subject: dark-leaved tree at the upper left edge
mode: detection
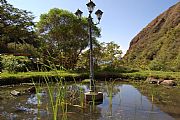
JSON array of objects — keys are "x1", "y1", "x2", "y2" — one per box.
[{"x1": 0, "y1": 0, "x2": 37, "y2": 53}]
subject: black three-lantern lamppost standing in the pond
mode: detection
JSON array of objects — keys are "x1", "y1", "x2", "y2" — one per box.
[{"x1": 75, "y1": 0, "x2": 103, "y2": 100}]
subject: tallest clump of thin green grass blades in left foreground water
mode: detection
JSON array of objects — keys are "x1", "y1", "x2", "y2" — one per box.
[{"x1": 30, "y1": 55, "x2": 67, "y2": 120}]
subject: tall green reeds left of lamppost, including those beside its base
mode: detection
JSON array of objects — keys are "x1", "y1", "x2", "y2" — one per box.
[{"x1": 32, "y1": 55, "x2": 89, "y2": 120}]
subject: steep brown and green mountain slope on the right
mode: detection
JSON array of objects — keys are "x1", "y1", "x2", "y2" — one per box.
[{"x1": 123, "y1": 2, "x2": 180, "y2": 71}]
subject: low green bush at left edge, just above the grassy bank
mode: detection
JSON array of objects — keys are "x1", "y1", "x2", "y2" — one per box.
[{"x1": 1, "y1": 55, "x2": 31, "y2": 73}]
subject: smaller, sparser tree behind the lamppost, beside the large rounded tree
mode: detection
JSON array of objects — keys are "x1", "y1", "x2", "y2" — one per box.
[{"x1": 78, "y1": 42, "x2": 122, "y2": 69}]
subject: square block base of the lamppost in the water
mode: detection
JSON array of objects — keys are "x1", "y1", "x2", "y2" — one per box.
[{"x1": 84, "y1": 91, "x2": 103, "y2": 102}]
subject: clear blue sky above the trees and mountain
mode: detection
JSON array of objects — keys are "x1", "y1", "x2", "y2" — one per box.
[{"x1": 7, "y1": 0, "x2": 179, "y2": 54}]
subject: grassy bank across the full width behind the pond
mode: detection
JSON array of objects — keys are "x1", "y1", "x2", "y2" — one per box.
[{"x1": 0, "y1": 71, "x2": 180, "y2": 85}]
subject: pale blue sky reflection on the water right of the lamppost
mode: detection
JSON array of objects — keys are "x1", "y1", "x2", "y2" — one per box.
[{"x1": 100, "y1": 85, "x2": 173, "y2": 120}]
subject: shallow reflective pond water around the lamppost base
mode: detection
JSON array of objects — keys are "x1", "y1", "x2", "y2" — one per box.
[{"x1": 0, "y1": 82, "x2": 180, "y2": 120}]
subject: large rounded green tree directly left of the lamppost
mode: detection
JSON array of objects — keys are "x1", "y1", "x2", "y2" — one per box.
[{"x1": 37, "y1": 8, "x2": 100, "y2": 69}]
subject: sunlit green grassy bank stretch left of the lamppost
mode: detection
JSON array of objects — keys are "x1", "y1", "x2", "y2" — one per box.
[{"x1": 0, "y1": 71, "x2": 83, "y2": 86}]
